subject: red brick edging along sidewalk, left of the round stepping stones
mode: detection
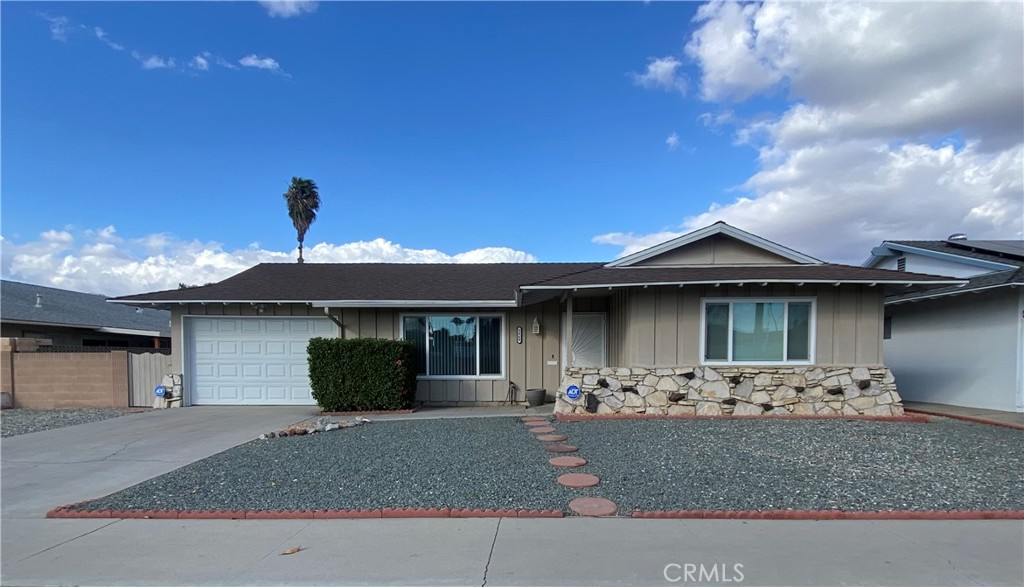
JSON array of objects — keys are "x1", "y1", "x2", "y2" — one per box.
[{"x1": 46, "y1": 506, "x2": 565, "y2": 519}]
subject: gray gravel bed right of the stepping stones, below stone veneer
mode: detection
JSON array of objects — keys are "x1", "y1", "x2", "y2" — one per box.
[{"x1": 559, "y1": 419, "x2": 1024, "y2": 515}]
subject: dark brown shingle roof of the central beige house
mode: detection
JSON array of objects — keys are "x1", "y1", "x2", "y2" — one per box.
[{"x1": 115, "y1": 263, "x2": 957, "y2": 302}]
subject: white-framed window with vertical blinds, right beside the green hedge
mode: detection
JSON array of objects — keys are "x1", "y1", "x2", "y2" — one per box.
[{"x1": 401, "y1": 313, "x2": 505, "y2": 379}]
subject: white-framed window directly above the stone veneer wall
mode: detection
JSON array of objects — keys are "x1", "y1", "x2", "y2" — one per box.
[{"x1": 700, "y1": 298, "x2": 815, "y2": 365}]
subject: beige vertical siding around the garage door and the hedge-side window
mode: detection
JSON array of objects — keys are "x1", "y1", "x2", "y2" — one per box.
[{"x1": 171, "y1": 300, "x2": 569, "y2": 404}]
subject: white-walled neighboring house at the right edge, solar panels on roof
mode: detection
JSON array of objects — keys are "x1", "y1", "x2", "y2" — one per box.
[{"x1": 863, "y1": 235, "x2": 1024, "y2": 412}]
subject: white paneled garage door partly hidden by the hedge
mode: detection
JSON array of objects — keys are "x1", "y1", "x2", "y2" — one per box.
[{"x1": 185, "y1": 318, "x2": 336, "y2": 406}]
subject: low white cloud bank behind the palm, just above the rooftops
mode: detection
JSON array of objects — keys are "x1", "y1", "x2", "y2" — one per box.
[{"x1": 0, "y1": 226, "x2": 537, "y2": 295}]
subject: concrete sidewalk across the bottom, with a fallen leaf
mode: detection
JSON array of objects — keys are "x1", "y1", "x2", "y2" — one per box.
[{"x1": 0, "y1": 518, "x2": 1024, "y2": 586}]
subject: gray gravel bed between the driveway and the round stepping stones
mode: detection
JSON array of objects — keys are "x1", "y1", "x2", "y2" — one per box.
[{"x1": 70, "y1": 418, "x2": 575, "y2": 510}]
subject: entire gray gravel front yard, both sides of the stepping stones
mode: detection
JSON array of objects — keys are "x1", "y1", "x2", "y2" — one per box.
[{"x1": 64, "y1": 418, "x2": 1024, "y2": 515}]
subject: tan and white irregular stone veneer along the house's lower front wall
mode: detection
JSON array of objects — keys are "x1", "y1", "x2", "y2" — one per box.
[{"x1": 555, "y1": 366, "x2": 903, "y2": 416}]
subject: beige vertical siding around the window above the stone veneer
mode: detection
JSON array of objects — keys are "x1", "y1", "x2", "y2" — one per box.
[{"x1": 609, "y1": 284, "x2": 884, "y2": 367}]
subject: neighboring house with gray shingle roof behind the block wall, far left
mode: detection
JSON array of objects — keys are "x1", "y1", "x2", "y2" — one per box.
[{"x1": 0, "y1": 281, "x2": 171, "y2": 348}]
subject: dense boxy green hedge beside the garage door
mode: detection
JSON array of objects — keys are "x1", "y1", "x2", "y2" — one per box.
[{"x1": 307, "y1": 338, "x2": 416, "y2": 412}]
